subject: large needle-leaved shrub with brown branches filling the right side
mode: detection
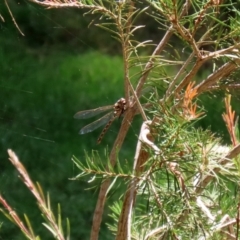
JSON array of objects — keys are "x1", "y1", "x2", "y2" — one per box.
[{"x1": 1, "y1": 0, "x2": 240, "y2": 240}]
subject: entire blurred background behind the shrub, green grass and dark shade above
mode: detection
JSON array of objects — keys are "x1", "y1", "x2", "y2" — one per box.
[{"x1": 0, "y1": 1, "x2": 240, "y2": 240}]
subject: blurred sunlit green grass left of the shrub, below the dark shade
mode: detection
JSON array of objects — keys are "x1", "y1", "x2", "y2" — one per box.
[{"x1": 0, "y1": 44, "x2": 139, "y2": 239}]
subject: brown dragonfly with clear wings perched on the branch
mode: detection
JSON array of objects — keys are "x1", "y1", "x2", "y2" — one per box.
[{"x1": 74, "y1": 98, "x2": 127, "y2": 144}]
